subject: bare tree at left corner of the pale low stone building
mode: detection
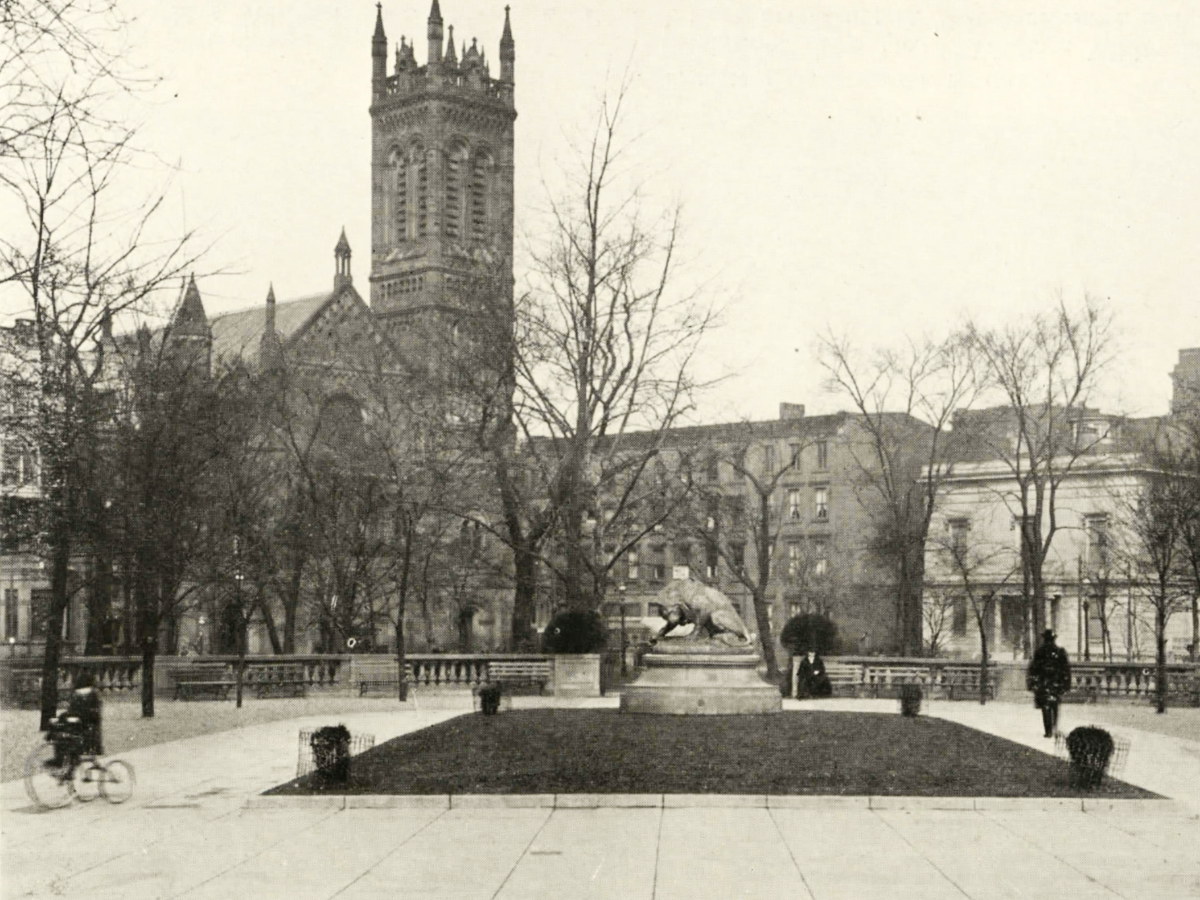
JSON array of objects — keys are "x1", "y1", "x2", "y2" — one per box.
[{"x1": 820, "y1": 334, "x2": 984, "y2": 654}]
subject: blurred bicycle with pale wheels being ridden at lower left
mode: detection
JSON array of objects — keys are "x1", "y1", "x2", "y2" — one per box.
[{"x1": 25, "y1": 719, "x2": 136, "y2": 809}]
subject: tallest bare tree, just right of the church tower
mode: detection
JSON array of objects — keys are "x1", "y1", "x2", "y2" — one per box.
[{"x1": 451, "y1": 89, "x2": 714, "y2": 646}]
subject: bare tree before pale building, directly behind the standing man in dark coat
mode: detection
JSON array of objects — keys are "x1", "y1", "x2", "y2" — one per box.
[{"x1": 964, "y1": 298, "x2": 1111, "y2": 655}]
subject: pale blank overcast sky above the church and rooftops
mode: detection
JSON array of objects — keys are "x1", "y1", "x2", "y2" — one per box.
[{"x1": 4, "y1": 0, "x2": 1200, "y2": 421}]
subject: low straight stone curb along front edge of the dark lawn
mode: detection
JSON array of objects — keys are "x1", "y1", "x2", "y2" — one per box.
[{"x1": 244, "y1": 793, "x2": 1189, "y2": 815}]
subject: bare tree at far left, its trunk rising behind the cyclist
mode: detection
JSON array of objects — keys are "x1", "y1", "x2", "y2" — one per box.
[{"x1": 0, "y1": 81, "x2": 194, "y2": 726}]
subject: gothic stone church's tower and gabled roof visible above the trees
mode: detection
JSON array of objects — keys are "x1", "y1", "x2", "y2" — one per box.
[{"x1": 170, "y1": 0, "x2": 516, "y2": 650}]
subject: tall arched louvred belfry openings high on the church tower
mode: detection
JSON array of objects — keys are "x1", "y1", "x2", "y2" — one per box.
[{"x1": 383, "y1": 142, "x2": 498, "y2": 246}]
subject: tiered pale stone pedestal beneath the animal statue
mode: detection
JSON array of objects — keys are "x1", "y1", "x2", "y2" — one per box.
[{"x1": 620, "y1": 640, "x2": 784, "y2": 715}]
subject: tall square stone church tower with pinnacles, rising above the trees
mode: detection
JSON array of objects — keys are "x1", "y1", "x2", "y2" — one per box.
[{"x1": 371, "y1": 0, "x2": 516, "y2": 357}]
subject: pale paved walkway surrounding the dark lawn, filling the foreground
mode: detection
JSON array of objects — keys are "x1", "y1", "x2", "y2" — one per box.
[{"x1": 0, "y1": 701, "x2": 1200, "y2": 900}]
